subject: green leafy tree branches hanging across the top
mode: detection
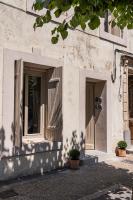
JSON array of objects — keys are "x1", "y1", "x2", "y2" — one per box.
[{"x1": 33, "y1": 0, "x2": 133, "y2": 44}]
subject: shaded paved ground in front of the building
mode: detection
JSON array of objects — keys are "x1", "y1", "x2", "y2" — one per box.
[{"x1": 0, "y1": 155, "x2": 133, "y2": 200}]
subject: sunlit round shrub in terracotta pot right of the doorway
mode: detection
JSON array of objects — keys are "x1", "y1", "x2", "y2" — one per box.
[{"x1": 116, "y1": 141, "x2": 127, "y2": 157}]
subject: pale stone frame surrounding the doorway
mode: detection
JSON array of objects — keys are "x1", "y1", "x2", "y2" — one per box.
[{"x1": 79, "y1": 69, "x2": 113, "y2": 153}]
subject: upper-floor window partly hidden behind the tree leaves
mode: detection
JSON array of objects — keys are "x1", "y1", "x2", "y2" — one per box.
[{"x1": 104, "y1": 11, "x2": 123, "y2": 38}]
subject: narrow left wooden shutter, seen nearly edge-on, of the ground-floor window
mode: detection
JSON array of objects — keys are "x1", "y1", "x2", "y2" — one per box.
[{"x1": 14, "y1": 60, "x2": 23, "y2": 147}]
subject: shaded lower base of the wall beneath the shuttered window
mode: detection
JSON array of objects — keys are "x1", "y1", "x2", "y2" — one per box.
[{"x1": 0, "y1": 151, "x2": 62, "y2": 181}]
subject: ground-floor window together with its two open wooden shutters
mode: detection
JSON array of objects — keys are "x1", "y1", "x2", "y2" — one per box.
[{"x1": 14, "y1": 60, "x2": 62, "y2": 147}]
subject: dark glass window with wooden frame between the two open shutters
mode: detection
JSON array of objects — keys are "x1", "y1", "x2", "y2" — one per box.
[{"x1": 23, "y1": 71, "x2": 46, "y2": 136}]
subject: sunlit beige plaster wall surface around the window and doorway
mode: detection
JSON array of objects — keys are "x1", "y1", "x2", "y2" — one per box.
[{"x1": 0, "y1": 0, "x2": 133, "y2": 178}]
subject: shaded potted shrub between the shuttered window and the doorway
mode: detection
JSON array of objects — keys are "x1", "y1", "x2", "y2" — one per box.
[{"x1": 69, "y1": 149, "x2": 80, "y2": 169}]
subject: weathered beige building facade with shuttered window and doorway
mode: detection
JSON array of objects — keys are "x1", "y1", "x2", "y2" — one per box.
[{"x1": 0, "y1": 0, "x2": 133, "y2": 180}]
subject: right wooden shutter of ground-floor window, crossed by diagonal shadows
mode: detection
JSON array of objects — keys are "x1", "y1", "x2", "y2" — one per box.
[{"x1": 46, "y1": 67, "x2": 62, "y2": 141}]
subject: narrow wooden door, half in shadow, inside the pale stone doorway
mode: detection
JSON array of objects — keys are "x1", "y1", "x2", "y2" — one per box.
[{"x1": 85, "y1": 82, "x2": 95, "y2": 149}]
